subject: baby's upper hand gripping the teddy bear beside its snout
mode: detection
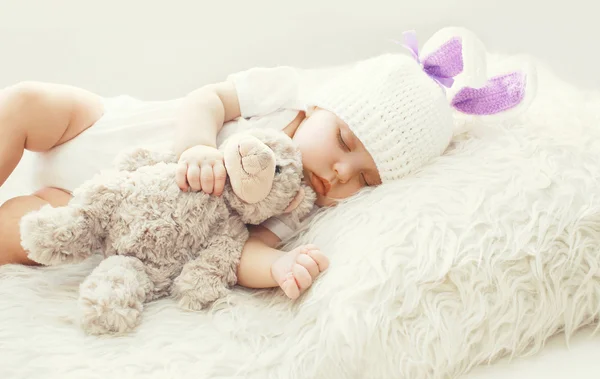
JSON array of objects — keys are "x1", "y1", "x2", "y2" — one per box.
[{"x1": 175, "y1": 145, "x2": 227, "y2": 196}]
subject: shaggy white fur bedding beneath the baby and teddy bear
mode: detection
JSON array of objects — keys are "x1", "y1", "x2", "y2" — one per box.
[{"x1": 0, "y1": 57, "x2": 600, "y2": 379}]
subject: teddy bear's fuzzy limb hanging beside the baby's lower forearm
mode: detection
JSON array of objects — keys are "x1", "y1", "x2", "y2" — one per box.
[{"x1": 172, "y1": 237, "x2": 244, "y2": 310}]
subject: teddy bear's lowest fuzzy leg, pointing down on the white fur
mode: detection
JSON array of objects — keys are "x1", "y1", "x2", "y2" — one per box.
[{"x1": 79, "y1": 255, "x2": 154, "y2": 334}]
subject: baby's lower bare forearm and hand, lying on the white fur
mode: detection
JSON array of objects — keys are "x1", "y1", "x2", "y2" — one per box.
[{"x1": 237, "y1": 226, "x2": 329, "y2": 299}]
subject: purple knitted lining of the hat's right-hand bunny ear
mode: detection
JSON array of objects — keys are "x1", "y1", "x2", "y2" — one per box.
[{"x1": 451, "y1": 72, "x2": 527, "y2": 115}]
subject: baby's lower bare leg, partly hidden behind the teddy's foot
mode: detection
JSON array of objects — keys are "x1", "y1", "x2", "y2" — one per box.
[{"x1": 0, "y1": 188, "x2": 71, "y2": 265}]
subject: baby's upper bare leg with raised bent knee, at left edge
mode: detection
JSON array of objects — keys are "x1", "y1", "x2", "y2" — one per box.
[{"x1": 0, "y1": 83, "x2": 104, "y2": 186}]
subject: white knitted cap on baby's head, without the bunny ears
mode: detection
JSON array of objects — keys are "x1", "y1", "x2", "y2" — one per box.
[{"x1": 308, "y1": 54, "x2": 453, "y2": 183}]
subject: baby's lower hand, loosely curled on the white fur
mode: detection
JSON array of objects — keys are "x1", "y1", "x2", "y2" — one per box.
[{"x1": 271, "y1": 245, "x2": 329, "y2": 300}]
